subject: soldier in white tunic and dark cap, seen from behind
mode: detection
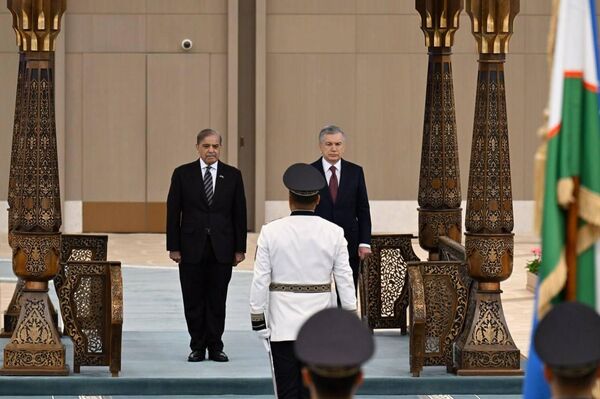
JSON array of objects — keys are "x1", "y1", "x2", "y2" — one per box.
[{"x1": 250, "y1": 164, "x2": 356, "y2": 399}]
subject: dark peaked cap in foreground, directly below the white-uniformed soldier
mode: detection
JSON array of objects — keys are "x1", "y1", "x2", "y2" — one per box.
[{"x1": 295, "y1": 308, "x2": 375, "y2": 377}]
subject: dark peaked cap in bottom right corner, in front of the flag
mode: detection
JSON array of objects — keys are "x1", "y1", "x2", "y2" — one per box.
[{"x1": 533, "y1": 302, "x2": 600, "y2": 377}]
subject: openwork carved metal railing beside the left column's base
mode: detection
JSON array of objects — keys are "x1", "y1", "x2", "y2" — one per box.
[{"x1": 54, "y1": 235, "x2": 123, "y2": 375}]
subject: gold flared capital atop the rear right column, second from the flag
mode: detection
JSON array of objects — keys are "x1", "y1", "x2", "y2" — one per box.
[{"x1": 415, "y1": 0, "x2": 463, "y2": 47}]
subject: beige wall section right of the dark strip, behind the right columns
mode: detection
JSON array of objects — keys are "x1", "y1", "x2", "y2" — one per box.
[{"x1": 266, "y1": 0, "x2": 550, "y2": 200}]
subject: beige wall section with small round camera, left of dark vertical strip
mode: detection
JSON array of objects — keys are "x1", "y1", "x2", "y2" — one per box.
[{"x1": 65, "y1": 0, "x2": 227, "y2": 202}]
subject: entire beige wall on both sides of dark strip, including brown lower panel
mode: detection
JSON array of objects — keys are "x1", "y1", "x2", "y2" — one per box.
[{"x1": 0, "y1": 0, "x2": 564, "y2": 231}]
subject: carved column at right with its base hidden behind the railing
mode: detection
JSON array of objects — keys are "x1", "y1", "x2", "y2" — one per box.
[{"x1": 415, "y1": 0, "x2": 463, "y2": 260}]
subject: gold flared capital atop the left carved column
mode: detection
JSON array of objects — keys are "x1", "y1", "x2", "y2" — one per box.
[{"x1": 7, "y1": 0, "x2": 67, "y2": 51}]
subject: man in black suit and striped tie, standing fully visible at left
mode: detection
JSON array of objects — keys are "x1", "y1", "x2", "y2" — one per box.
[{"x1": 167, "y1": 129, "x2": 247, "y2": 362}]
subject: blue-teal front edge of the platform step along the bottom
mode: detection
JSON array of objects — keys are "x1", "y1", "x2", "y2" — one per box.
[{"x1": 0, "y1": 377, "x2": 523, "y2": 396}]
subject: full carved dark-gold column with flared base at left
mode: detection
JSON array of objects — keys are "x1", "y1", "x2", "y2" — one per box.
[{"x1": 0, "y1": 0, "x2": 69, "y2": 375}]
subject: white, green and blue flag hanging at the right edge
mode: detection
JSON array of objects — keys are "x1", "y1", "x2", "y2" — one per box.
[{"x1": 523, "y1": 0, "x2": 600, "y2": 399}]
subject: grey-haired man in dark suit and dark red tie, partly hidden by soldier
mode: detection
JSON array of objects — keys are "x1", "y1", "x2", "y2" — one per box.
[{"x1": 312, "y1": 125, "x2": 371, "y2": 288}]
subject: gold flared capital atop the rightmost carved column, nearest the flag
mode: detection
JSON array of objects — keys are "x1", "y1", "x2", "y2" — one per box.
[{"x1": 466, "y1": 0, "x2": 520, "y2": 54}]
